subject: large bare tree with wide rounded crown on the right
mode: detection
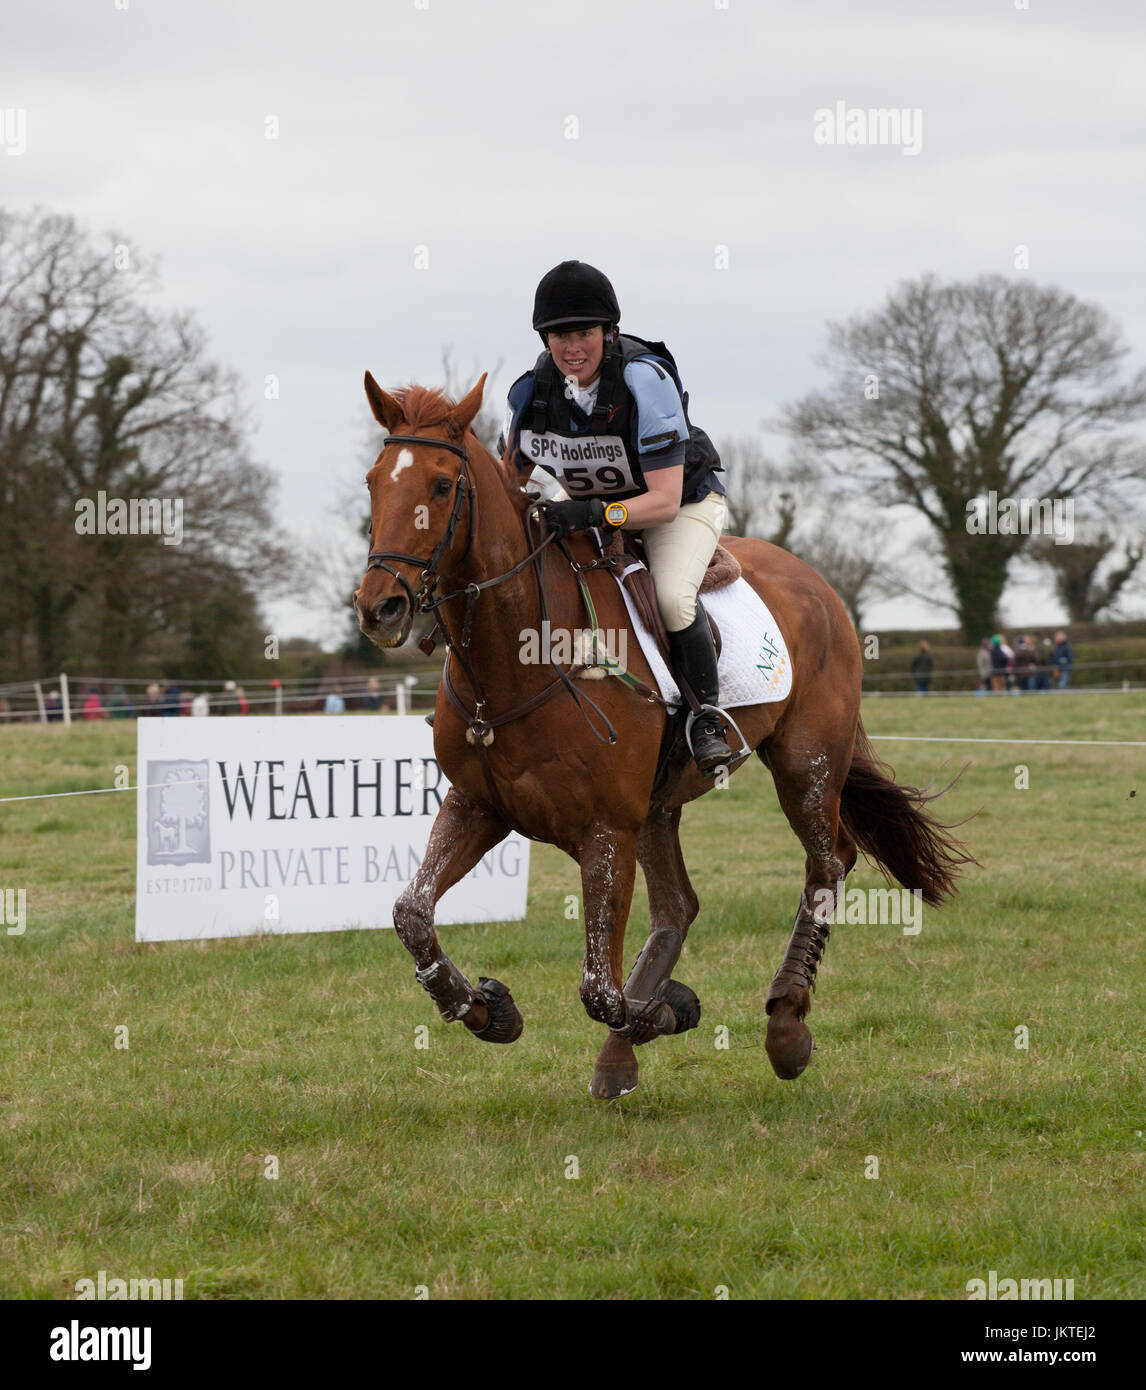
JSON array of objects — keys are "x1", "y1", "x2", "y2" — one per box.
[{"x1": 784, "y1": 275, "x2": 1146, "y2": 639}]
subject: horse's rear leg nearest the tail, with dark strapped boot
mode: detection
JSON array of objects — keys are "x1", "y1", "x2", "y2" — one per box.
[{"x1": 758, "y1": 731, "x2": 855, "y2": 1081}]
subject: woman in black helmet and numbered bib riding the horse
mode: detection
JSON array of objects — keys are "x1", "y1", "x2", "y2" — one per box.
[{"x1": 498, "y1": 261, "x2": 732, "y2": 776}]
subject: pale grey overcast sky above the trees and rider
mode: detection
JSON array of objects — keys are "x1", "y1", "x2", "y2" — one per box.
[{"x1": 0, "y1": 0, "x2": 1146, "y2": 637}]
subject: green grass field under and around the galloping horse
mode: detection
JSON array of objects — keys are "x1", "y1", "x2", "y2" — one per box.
[{"x1": 0, "y1": 694, "x2": 1146, "y2": 1300}]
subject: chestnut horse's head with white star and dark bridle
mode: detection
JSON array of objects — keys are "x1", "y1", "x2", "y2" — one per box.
[{"x1": 353, "y1": 371, "x2": 485, "y2": 646}]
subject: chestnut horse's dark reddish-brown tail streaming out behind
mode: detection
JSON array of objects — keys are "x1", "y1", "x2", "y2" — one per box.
[{"x1": 840, "y1": 721, "x2": 979, "y2": 906}]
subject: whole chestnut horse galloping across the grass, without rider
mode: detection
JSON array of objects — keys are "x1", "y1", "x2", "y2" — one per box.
[{"x1": 353, "y1": 373, "x2": 971, "y2": 1097}]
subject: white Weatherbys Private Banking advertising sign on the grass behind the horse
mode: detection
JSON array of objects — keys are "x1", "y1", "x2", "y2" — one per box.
[{"x1": 135, "y1": 714, "x2": 530, "y2": 941}]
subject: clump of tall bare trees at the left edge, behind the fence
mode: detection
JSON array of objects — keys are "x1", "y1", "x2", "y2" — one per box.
[{"x1": 0, "y1": 211, "x2": 285, "y2": 674}]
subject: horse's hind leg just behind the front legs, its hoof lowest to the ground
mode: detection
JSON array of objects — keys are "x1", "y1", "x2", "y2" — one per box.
[{"x1": 590, "y1": 808, "x2": 700, "y2": 1097}]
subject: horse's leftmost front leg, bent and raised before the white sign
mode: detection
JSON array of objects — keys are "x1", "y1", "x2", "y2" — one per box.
[{"x1": 394, "y1": 787, "x2": 522, "y2": 1043}]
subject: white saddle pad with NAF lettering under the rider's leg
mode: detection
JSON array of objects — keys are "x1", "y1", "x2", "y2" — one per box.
[{"x1": 618, "y1": 564, "x2": 791, "y2": 709}]
